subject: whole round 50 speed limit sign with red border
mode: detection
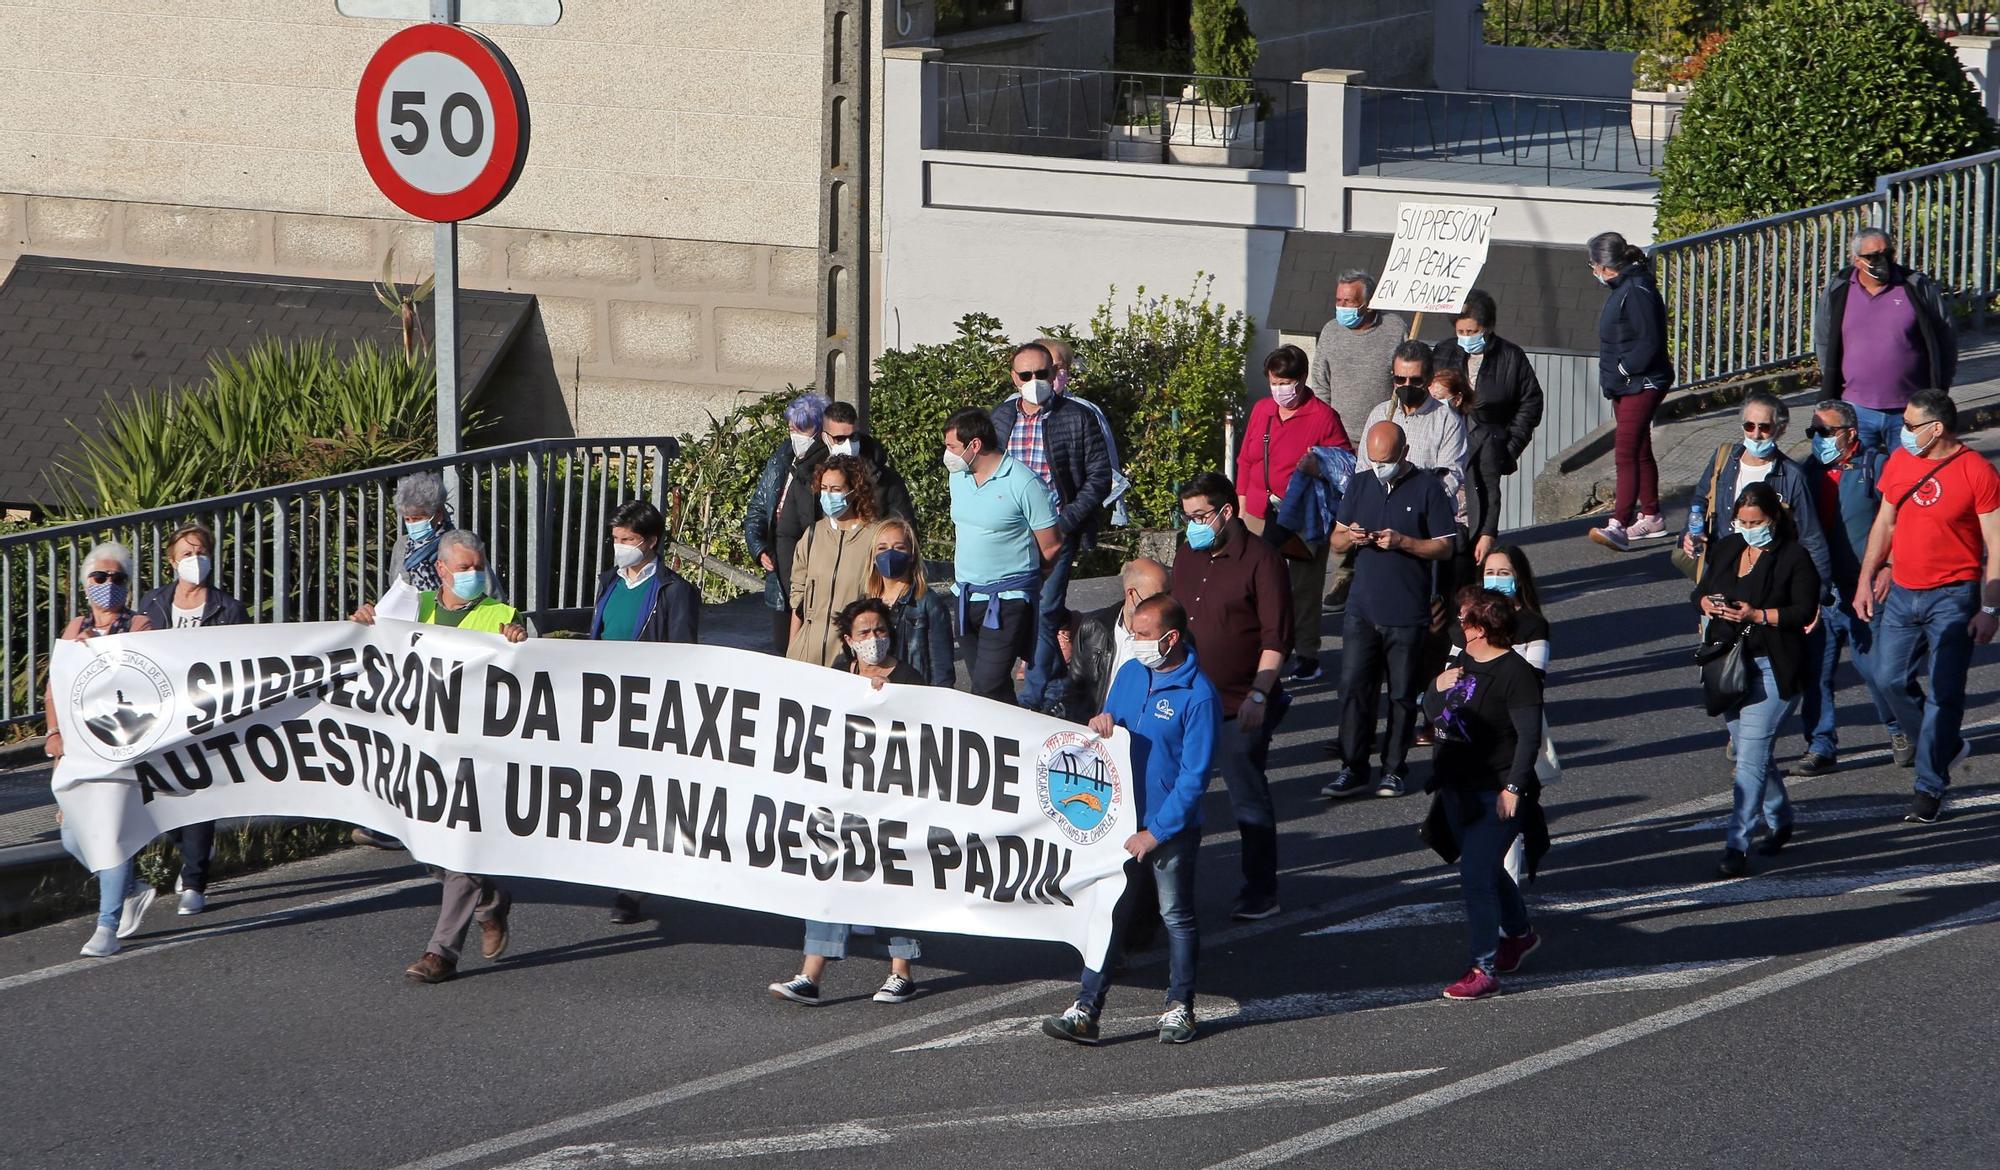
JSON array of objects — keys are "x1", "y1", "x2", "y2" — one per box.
[{"x1": 354, "y1": 24, "x2": 528, "y2": 224}]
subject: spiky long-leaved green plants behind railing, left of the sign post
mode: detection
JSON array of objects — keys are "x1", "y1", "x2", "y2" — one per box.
[{"x1": 48, "y1": 338, "x2": 480, "y2": 518}]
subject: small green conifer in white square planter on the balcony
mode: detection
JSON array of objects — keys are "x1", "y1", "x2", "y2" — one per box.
[{"x1": 1166, "y1": 0, "x2": 1264, "y2": 166}]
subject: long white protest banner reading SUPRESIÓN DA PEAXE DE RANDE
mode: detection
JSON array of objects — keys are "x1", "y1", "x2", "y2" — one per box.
[{"x1": 52, "y1": 622, "x2": 1136, "y2": 966}]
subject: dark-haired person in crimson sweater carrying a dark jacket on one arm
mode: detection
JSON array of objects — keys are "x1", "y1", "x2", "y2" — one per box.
[{"x1": 1236, "y1": 346, "x2": 1354, "y2": 682}]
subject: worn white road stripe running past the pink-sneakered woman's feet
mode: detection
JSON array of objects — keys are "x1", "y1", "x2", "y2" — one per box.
[{"x1": 896, "y1": 958, "x2": 1764, "y2": 1052}]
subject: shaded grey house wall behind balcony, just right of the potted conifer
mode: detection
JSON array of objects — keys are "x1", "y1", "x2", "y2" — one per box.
[{"x1": 1240, "y1": 0, "x2": 1432, "y2": 86}]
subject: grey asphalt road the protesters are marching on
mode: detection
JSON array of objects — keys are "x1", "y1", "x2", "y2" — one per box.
[{"x1": 0, "y1": 524, "x2": 2000, "y2": 1170}]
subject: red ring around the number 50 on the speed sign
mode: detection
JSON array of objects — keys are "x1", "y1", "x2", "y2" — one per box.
[{"x1": 354, "y1": 24, "x2": 528, "y2": 224}]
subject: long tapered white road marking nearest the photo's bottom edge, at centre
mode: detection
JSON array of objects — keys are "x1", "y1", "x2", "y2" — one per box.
[{"x1": 504, "y1": 1068, "x2": 1440, "y2": 1170}]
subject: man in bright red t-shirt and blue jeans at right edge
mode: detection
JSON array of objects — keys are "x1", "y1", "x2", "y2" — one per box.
[{"x1": 1854, "y1": 390, "x2": 2000, "y2": 824}]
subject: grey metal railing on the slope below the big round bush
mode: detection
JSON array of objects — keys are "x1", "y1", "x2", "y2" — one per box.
[{"x1": 1650, "y1": 150, "x2": 2000, "y2": 386}]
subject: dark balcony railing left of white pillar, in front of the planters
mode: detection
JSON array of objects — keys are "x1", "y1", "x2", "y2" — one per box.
[{"x1": 924, "y1": 62, "x2": 1306, "y2": 170}]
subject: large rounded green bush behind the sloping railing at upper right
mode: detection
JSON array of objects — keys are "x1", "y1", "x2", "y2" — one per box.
[{"x1": 1654, "y1": 0, "x2": 1994, "y2": 240}]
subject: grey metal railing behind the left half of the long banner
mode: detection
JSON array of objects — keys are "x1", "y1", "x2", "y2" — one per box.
[{"x1": 0, "y1": 436, "x2": 680, "y2": 726}]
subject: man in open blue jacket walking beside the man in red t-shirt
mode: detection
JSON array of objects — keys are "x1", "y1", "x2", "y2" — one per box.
[{"x1": 1792, "y1": 398, "x2": 1924, "y2": 776}]
